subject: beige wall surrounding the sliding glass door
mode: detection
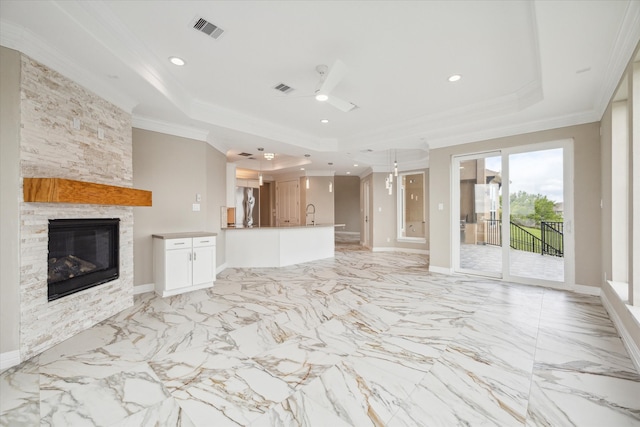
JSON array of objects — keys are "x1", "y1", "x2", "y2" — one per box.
[{"x1": 429, "y1": 123, "x2": 602, "y2": 287}]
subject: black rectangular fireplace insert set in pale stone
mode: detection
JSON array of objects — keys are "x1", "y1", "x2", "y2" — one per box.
[{"x1": 47, "y1": 218, "x2": 120, "y2": 301}]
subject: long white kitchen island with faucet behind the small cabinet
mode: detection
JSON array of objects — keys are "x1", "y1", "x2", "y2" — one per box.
[{"x1": 225, "y1": 224, "x2": 339, "y2": 268}]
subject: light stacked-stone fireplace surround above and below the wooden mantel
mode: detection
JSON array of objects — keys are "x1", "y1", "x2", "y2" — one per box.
[{"x1": 19, "y1": 55, "x2": 133, "y2": 360}]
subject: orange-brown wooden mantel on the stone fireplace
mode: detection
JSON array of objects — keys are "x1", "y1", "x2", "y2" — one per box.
[{"x1": 23, "y1": 178, "x2": 151, "y2": 206}]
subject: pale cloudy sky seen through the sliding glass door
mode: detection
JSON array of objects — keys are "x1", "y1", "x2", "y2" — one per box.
[{"x1": 485, "y1": 148, "x2": 564, "y2": 203}]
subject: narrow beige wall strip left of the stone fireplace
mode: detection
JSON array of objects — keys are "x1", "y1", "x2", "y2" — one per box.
[{"x1": 0, "y1": 47, "x2": 21, "y2": 354}]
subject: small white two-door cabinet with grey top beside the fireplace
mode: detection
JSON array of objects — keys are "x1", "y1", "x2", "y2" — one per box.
[{"x1": 153, "y1": 233, "x2": 216, "y2": 297}]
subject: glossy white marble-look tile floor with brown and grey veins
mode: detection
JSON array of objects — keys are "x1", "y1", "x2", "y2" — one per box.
[{"x1": 0, "y1": 245, "x2": 640, "y2": 427}]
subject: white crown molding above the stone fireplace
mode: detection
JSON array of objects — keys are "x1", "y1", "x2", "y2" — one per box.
[{"x1": 0, "y1": 19, "x2": 138, "y2": 113}]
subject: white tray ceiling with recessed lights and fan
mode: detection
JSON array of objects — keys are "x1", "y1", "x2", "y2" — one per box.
[{"x1": 0, "y1": 0, "x2": 640, "y2": 174}]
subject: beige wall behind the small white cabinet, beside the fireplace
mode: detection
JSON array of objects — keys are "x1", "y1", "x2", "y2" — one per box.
[{"x1": 133, "y1": 128, "x2": 226, "y2": 285}]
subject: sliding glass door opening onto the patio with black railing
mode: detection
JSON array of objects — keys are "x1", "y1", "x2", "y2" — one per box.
[{"x1": 452, "y1": 141, "x2": 573, "y2": 284}]
